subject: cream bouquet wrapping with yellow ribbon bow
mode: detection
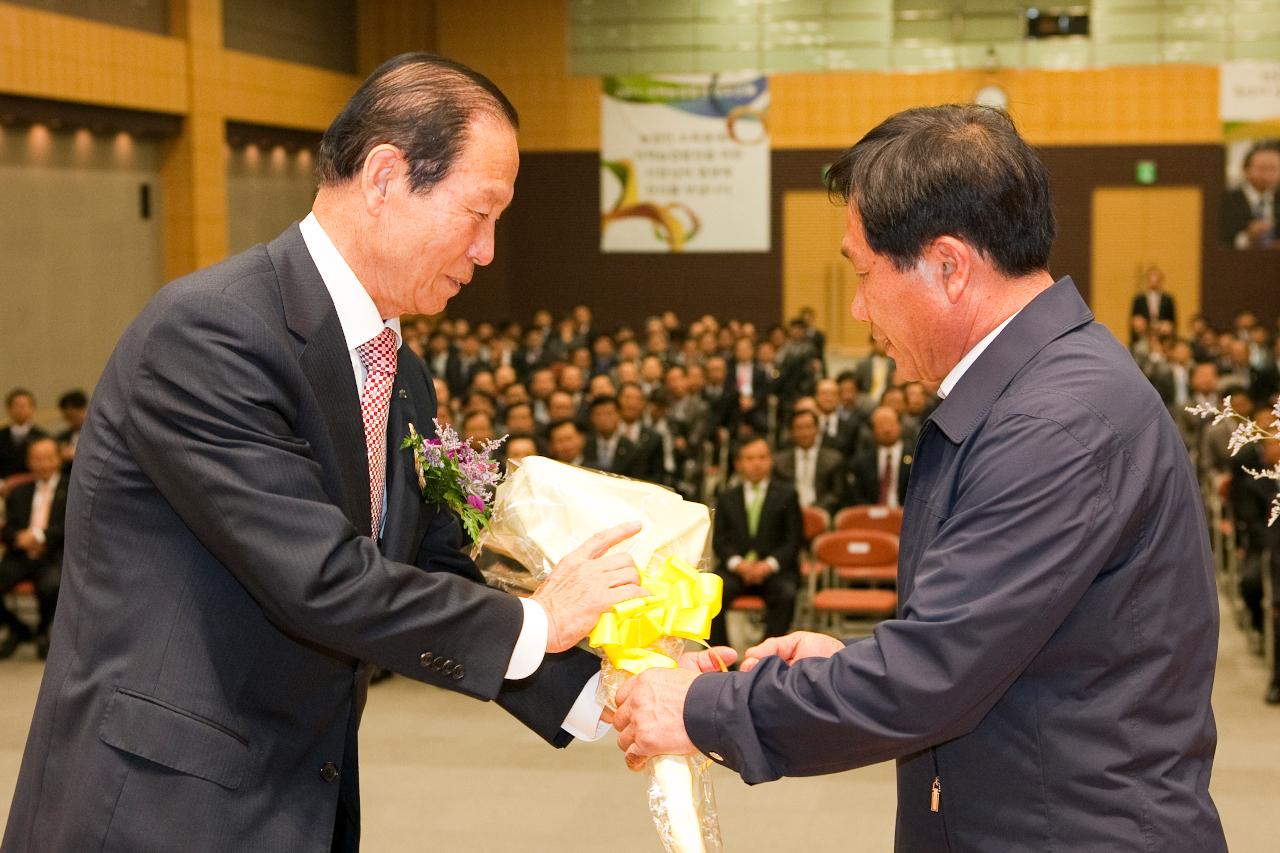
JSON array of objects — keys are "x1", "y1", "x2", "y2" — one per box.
[{"x1": 474, "y1": 456, "x2": 722, "y2": 853}]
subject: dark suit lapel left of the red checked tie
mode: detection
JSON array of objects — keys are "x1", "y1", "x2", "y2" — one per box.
[{"x1": 266, "y1": 224, "x2": 372, "y2": 535}]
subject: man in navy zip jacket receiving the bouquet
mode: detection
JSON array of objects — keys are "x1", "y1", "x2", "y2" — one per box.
[{"x1": 614, "y1": 105, "x2": 1226, "y2": 853}]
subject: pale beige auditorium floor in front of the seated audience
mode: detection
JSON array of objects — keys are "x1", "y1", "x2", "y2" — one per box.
[{"x1": 0, "y1": 594, "x2": 1280, "y2": 853}]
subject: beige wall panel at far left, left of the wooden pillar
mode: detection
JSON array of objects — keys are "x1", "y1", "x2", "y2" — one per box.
[{"x1": 0, "y1": 126, "x2": 164, "y2": 423}]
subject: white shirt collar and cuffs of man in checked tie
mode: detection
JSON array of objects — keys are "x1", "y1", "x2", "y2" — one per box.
[{"x1": 298, "y1": 213, "x2": 607, "y2": 740}]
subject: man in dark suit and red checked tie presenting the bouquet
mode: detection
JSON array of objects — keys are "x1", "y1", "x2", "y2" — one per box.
[{"x1": 3, "y1": 54, "x2": 640, "y2": 853}]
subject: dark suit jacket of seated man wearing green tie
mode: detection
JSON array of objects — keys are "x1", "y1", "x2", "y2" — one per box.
[{"x1": 712, "y1": 478, "x2": 804, "y2": 575}]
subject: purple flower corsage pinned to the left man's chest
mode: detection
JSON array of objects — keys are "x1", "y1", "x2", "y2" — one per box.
[{"x1": 401, "y1": 419, "x2": 507, "y2": 542}]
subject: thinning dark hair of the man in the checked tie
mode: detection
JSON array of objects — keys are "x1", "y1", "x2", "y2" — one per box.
[{"x1": 316, "y1": 53, "x2": 520, "y2": 192}]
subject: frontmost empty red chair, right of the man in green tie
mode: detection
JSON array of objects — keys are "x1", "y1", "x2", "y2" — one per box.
[{"x1": 809, "y1": 530, "x2": 897, "y2": 633}]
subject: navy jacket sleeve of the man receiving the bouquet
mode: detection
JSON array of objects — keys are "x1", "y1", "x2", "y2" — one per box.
[{"x1": 684, "y1": 416, "x2": 1121, "y2": 784}]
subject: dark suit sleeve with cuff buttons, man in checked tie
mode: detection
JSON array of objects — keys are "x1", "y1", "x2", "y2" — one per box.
[{"x1": 124, "y1": 289, "x2": 524, "y2": 699}]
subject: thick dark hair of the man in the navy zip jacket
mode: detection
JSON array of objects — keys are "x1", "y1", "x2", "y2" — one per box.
[{"x1": 827, "y1": 104, "x2": 1053, "y2": 277}]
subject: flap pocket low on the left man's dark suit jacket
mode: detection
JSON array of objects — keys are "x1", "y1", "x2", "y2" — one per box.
[{"x1": 99, "y1": 688, "x2": 248, "y2": 790}]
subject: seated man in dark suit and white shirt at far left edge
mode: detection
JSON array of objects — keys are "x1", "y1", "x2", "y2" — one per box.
[{"x1": 0, "y1": 435, "x2": 70, "y2": 658}]
